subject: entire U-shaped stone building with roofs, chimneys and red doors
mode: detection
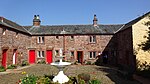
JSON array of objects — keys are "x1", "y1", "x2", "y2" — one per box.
[{"x1": 0, "y1": 13, "x2": 149, "y2": 70}]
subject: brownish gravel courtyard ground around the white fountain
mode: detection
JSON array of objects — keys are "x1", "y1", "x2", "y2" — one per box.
[{"x1": 0, "y1": 64, "x2": 139, "y2": 84}]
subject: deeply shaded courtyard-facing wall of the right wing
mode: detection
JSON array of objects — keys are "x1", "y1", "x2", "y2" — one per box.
[{"x1": 116, "y1": 27, "x2": 135, "y2": 69}]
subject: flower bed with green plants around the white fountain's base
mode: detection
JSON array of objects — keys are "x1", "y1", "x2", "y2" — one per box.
[{"x1": 18, "y1": 73, "x2": 101, "y2": 84}]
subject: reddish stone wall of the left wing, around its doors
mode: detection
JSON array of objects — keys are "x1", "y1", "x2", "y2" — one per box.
[{"x1": 0, "y1": 25, "x2": 31, "y2": 65}]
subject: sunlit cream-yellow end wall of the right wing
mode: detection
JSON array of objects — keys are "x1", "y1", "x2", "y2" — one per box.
[{"x1": 132, "y1": 17, "x2": 150, "y2": 64}]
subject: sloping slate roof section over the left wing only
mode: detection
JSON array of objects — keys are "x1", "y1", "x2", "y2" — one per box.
[{"x1": 0, "y1": 17, "x2": 29, "y2": 34}]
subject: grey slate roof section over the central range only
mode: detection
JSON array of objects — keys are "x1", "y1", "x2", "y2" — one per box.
[{"x1": 24, "y1": 24, "x2": 123, "y2": 35}]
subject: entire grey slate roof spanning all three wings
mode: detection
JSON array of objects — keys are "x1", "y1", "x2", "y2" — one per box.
[{"x1": 0, "y1": 12, "x2": 150, "y2": 35}]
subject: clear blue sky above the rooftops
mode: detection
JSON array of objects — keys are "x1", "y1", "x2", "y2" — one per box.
[{"x1": 0, "y1": 0, "x2": 150, "y2": 26}]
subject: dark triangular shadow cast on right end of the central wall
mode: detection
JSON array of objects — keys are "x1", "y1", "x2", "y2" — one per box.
[{"x1": 95, "y1": 36, "x2": 118, "y2": 66}]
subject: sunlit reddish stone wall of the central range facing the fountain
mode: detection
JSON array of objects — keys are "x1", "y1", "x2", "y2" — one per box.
[{"x1": 31, "y1": 35, "x2": 112, "y2": 61}]
